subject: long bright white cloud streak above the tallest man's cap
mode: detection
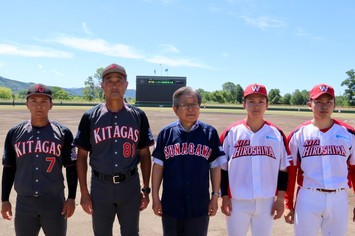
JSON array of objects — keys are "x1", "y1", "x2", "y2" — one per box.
[{"x1": 51, "y1": 37, "x2": 144, "y2": 59}]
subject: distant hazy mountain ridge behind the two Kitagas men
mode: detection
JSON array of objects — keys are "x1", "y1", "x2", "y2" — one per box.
[{"x1": 0, "y1": 76, "x2": 136, "y2": 98}]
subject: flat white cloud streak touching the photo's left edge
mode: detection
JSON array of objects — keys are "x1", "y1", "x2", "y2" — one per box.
[{"x1": 0, "y1": 44, "x2": 72, "y2": 58}]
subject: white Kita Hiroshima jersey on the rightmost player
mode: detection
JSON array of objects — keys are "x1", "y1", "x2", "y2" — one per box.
[{"x1": 288, "y1": 120, "x2": 355, "y2": 189}]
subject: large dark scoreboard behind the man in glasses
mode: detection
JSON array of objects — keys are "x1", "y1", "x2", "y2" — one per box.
[{"x1": 136, "y1": 75, "x2": 186, "y2": 105}]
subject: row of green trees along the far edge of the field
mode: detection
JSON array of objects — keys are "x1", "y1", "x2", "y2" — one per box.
[{"x1": 0, "y1": 68, "x2": 355, "y2": 107}]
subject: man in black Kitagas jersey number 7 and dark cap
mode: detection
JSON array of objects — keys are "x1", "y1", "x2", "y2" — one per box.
[{"x1": 1, "y1": 84, "x2": 77, "y2": 236}]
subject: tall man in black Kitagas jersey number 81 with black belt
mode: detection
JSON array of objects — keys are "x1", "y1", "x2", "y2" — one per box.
[{"x1": 74, "y1": 64, "x2": 154, "y2": 236}]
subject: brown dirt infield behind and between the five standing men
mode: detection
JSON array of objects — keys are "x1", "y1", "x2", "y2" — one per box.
[{"x1": 0, "y1": 106, "x2": 355, "y2": 236}]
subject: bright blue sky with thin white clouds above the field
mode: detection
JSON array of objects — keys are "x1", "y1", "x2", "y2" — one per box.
[{"x1": 0, "y1": 0, "x2": 355, "y2": 95}]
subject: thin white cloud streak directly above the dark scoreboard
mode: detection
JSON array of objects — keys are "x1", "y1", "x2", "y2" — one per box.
[{"x1": 146, "y1": 55, "x2": 213, "y2": 69}]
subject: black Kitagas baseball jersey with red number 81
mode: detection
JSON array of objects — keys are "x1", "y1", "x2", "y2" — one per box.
[{"x1": 74, "y1": 103, "x2": 154, "y2": 174}]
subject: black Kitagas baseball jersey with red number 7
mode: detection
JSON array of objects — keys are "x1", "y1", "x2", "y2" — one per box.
[{"x1": 2, "y1": 121, "x2": 76, "y2": 196}]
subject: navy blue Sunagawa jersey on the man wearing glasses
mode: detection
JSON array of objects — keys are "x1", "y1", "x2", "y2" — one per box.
[{"x1": 152, "y1": 121, "x2": 225, "y2": 219}]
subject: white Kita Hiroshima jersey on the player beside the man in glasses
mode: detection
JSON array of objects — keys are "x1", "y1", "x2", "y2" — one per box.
[{"x1": 221, "y1": 120, "x2": 289, "y2": 199}]
